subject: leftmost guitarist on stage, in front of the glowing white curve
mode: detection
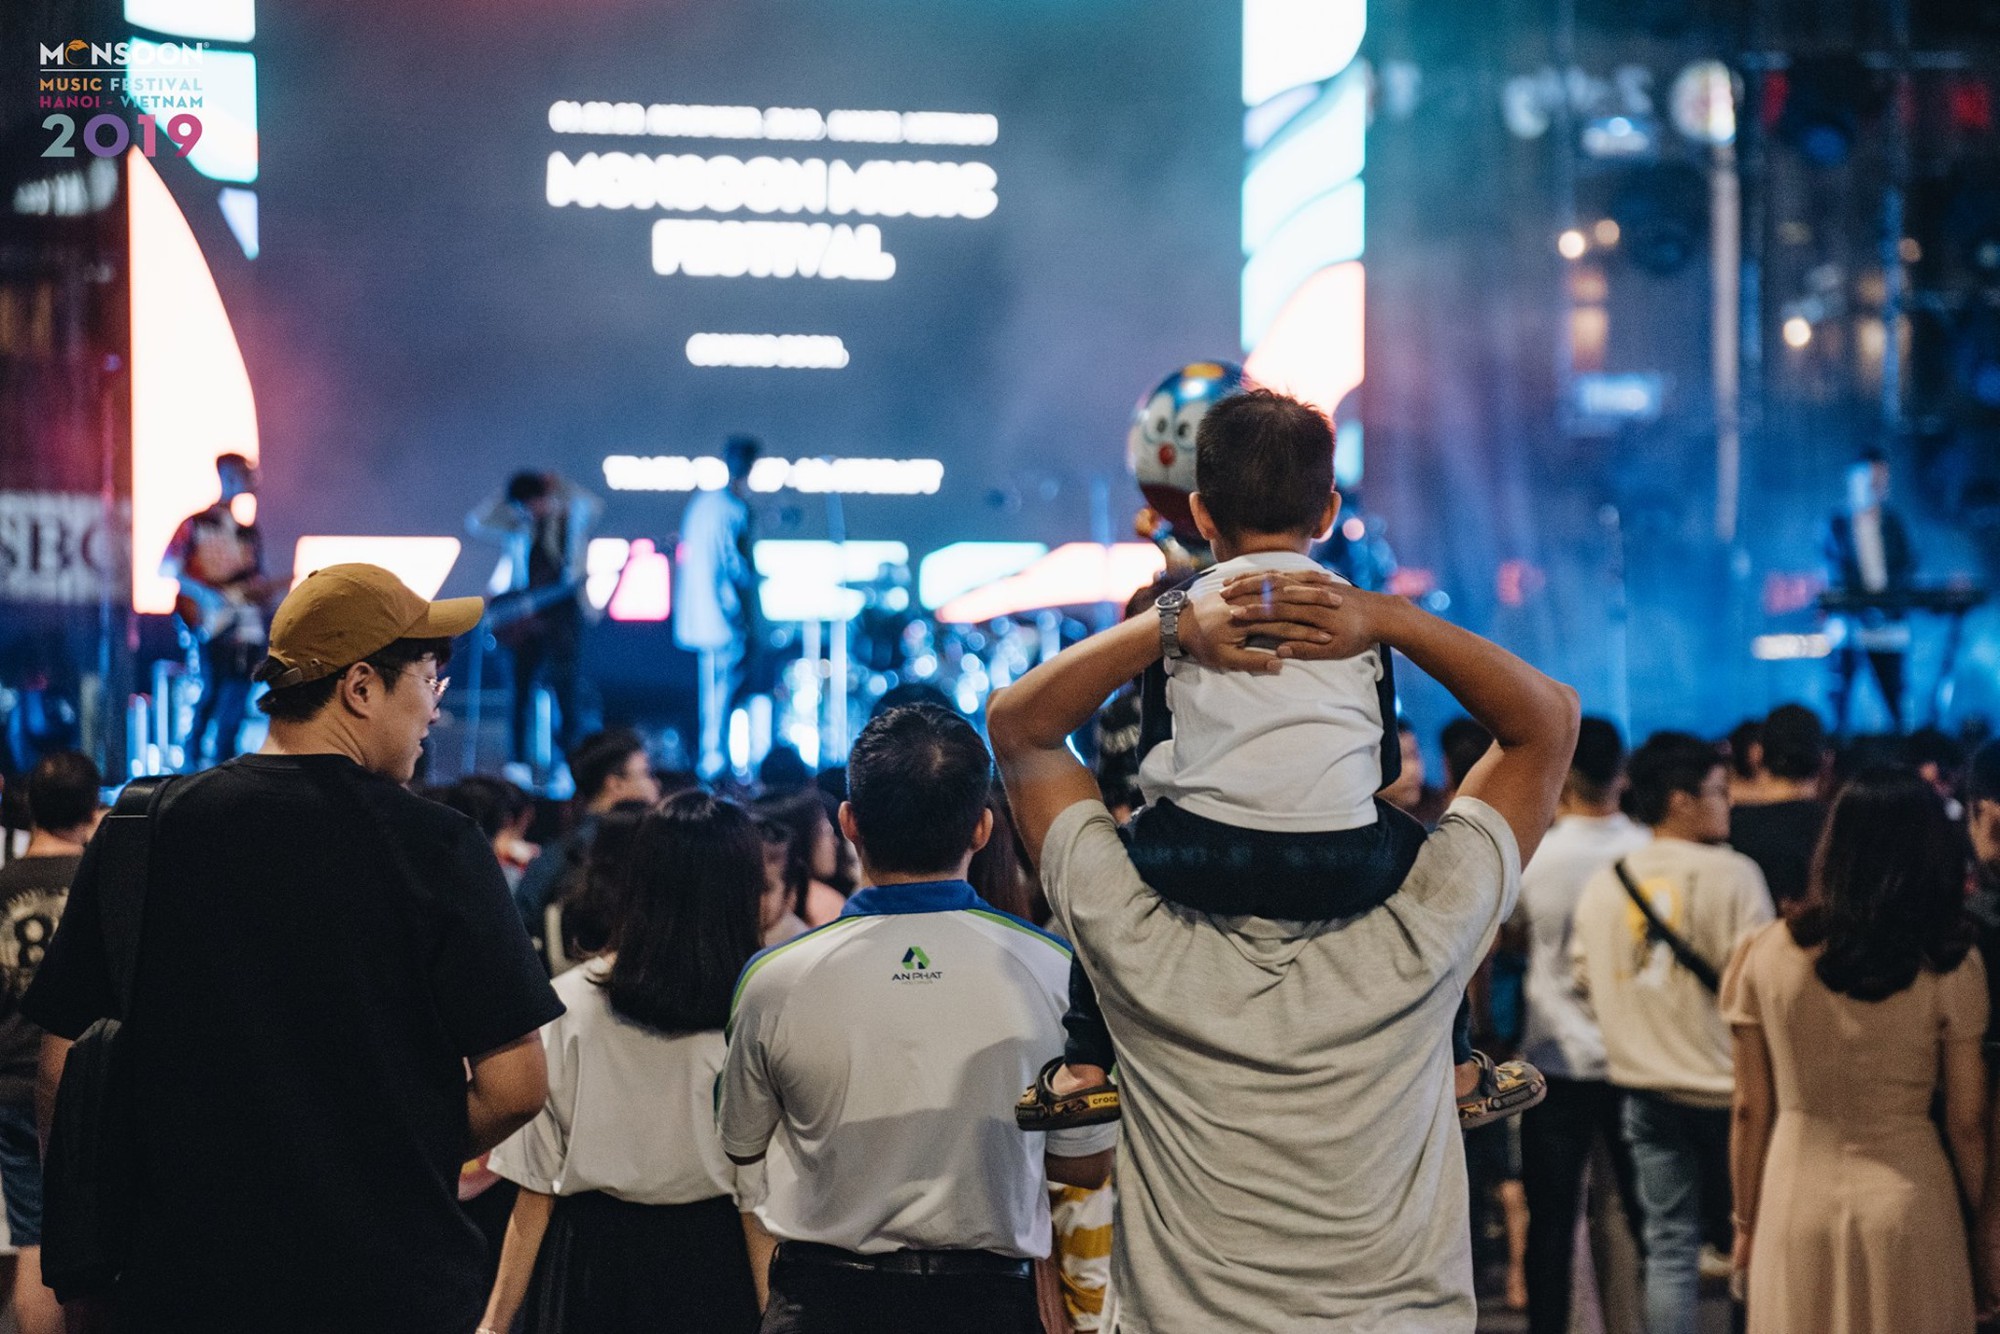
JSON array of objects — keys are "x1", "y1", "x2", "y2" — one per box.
[{"x1": 160, "y1": 454, "x2": 284, "y2": 772}]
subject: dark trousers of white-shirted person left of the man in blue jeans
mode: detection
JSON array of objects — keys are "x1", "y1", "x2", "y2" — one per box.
[{"x1": 1520, "y1": 1078, "x2": 1638, "y2": 1334}]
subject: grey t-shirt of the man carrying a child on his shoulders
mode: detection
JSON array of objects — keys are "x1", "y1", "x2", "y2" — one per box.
[{"x1": 1042, "y1": 798, "x2": 1520, "y2": 1334}]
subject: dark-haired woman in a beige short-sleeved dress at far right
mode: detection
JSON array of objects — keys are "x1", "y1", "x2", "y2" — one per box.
[{"x1": 1722, "y1": 768, "x2": 1986, "y2": 1334}]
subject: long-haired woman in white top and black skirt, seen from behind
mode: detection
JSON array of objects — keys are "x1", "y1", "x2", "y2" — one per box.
[{"x1": 482, "y1": 792, "x2": 764, "y2": 1334}]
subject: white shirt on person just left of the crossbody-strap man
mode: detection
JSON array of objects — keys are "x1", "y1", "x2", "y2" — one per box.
[{"x1": 1516, "y1": 814, "x2": 1652, "y2": 1080}]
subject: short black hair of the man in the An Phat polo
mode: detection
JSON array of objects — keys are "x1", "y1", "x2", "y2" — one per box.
[{"x1": 848, "y1": 704, "x2": 994, "y2": 874}]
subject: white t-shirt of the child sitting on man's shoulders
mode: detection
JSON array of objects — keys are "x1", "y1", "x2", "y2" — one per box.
[{"x1": 1138, "y1": 552, "x2": 1382, "y2": 832}]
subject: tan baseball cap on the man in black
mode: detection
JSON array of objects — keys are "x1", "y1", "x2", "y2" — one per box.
[{"x1": 258, "y1": 564, "x2": 486, "y2": 690}]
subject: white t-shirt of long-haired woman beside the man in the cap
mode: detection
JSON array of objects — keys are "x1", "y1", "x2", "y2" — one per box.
[{"x1": 488, "y1": 958, "x2": 754, "y2": 1204}]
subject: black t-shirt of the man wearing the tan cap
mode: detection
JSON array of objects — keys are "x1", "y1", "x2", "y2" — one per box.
[{"x1": 22, "y1": 756, "x2": 562, "y2": 1334}]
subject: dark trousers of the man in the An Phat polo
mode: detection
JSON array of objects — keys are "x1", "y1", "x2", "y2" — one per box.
[{"x1": 760, "y1": 1244, "x2": 1042, "y2": 1334}]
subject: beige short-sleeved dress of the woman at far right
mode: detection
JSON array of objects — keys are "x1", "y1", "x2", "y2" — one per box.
[{"x1": 1722, "y1": 922, "x2": 1986, "y2": 1334}]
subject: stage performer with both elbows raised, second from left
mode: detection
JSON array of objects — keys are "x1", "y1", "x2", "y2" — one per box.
[{"x1": 466, "y1": 472, "x2": 604, "y2": 764}]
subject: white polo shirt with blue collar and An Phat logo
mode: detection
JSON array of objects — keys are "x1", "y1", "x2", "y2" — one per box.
[{"x1": 716, "y1": 880, "x2": 1118, "y2": 1258}]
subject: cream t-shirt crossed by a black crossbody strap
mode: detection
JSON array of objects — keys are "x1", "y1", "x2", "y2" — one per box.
[{"x1": 1570, "y1": 838, "x2": 1772, "y2": 1108}]
